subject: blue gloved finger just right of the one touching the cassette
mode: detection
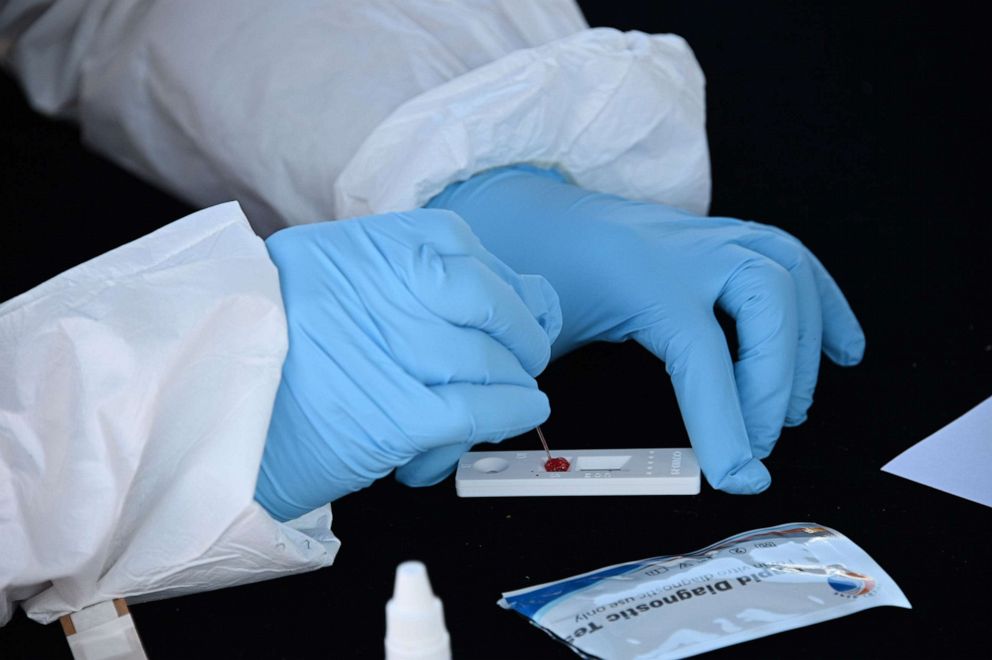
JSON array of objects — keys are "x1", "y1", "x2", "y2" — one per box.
[{"x1": 717, "y1": 251, "x2": 799, "y2": 458}]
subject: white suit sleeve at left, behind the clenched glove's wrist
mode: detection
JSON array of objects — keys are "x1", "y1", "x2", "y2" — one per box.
[{"x1": 0, "y1": 203, "x2": 339, "y2": 625}]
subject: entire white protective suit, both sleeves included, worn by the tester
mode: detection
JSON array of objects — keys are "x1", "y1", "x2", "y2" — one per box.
[{"x1": 0, "y1": 0, "x2": 709, "y2": 624}]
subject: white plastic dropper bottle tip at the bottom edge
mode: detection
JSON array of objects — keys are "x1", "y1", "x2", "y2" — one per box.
[{"x1": 386, "y1": 561, "x2": 451, "y2": 660}]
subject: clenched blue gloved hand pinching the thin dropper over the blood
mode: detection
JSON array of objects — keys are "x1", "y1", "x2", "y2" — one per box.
[{"x1": 255, "y1": 210, "x2": 561, "y2": 520}]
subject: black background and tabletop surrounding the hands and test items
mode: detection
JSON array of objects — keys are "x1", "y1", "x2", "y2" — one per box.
[{"x1": 0, "y1": 1, "x2": 992, "y2": 658}]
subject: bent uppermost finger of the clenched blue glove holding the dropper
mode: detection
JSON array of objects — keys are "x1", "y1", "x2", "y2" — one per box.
[{"x1": 409, "y1": 245, "x2": 561, "y2": 375}]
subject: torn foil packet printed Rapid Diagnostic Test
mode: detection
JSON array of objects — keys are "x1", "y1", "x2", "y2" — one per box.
[{"x1": 499, "y1": 523, "x2": 911, "y2": 660}]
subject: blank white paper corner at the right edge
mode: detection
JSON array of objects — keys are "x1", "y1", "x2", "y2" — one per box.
[{"x1": 882, "y1": 397, "x2": 992, "y2": 507}]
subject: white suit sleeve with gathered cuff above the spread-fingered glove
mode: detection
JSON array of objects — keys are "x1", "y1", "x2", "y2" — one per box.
[{"x1": 0, "y1": 0, "x2": 710, "y2": 235}]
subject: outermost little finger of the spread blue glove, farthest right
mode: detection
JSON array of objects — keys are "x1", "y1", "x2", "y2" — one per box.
[{"x1": 749, "y1": 223, "x2": 865, "y2": 367}]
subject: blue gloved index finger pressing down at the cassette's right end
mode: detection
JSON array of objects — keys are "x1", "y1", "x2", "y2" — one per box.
[{"x1": 634, "y1": 318, "x2": 771, "y2": 494}]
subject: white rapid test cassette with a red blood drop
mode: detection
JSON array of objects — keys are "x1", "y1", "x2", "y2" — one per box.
[{"x1": 455, "y1": 448, "x2": 699, "y2": 497}]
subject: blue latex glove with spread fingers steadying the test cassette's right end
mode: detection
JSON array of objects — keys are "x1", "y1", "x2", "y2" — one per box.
[{"x1": 430, "y1": 166, "x2": 865, "y2": 493}]
